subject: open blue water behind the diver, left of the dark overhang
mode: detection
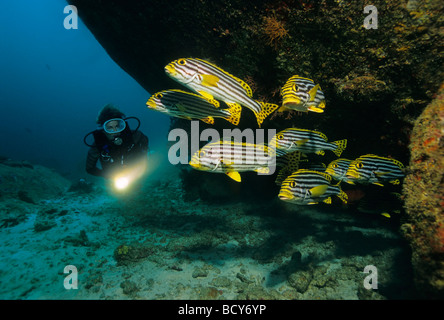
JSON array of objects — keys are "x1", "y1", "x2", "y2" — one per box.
[{"x1": 0, "y1": 0, "x2": 170, "y2": 178}]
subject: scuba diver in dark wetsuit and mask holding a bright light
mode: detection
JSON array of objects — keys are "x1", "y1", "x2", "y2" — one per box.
[{"x1": 83, "y1": 104, "x2": 149, "y2": 189}]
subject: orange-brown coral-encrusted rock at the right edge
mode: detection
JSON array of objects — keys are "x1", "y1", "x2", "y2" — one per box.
[{"x1": 402, "y1": 84, "x2": 444, "y2": 298}]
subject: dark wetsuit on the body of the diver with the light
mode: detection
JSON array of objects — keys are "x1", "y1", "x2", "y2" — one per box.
[{"x1": 86, "y1": 130, "x2": 148, "y2": 178}]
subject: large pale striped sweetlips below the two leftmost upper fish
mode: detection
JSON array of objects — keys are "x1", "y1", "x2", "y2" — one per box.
[{"x1": 189, "y1": 140, "x2": 276, "y2": 182}]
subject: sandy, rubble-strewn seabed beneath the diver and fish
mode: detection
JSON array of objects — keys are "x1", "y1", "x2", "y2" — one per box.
[{"x1": 0, "y1": 165, "x2": 414, "y2": 300}]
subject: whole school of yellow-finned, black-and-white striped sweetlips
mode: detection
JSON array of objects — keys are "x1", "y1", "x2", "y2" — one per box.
[{"x1": 146, "y1": 58, "x2": 405, "y2": 210}]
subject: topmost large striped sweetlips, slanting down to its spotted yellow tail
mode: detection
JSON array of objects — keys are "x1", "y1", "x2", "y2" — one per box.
[{"x1": 165, "y1": 58, "x2": 279, "y2": 127}]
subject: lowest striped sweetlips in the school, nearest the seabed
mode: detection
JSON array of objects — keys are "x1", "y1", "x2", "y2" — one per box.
[{"x1": 279, "y1": 169, "x2": 347, "y2": 205}]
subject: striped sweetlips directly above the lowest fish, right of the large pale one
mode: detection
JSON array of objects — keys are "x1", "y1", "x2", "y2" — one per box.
[{"x1": 269, "y1": 128, "x2": 347, "y2": 157}]
